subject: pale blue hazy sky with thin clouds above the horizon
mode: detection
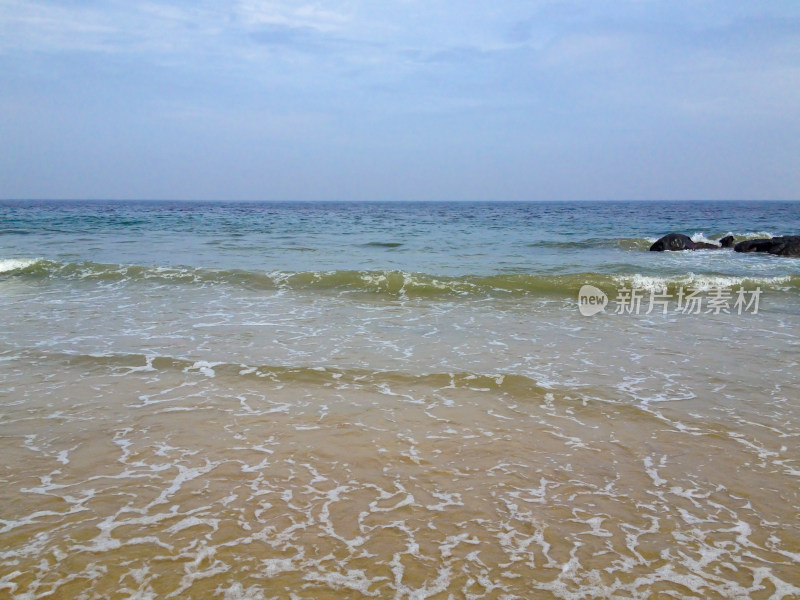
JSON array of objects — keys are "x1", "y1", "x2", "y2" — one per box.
[{"x1": 0, "y1": 0, "x2": 800, "y2": 201}]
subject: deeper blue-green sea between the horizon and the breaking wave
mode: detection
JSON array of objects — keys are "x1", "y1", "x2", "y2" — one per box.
[{"x1": 0, "y1": 201, "x2": 800, "y2": 276}]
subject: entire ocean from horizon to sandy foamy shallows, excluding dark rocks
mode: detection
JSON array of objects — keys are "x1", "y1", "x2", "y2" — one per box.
[{"x1": 0, "y1": 201, "x2": 800, "y2": 600}]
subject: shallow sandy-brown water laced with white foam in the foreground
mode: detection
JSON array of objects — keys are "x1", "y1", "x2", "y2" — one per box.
[{"x1": 0, "y1": 358, "x2": 800, "y2": 598}]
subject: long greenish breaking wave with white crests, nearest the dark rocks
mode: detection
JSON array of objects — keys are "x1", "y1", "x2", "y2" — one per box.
[{"x1": 0, "y1": 259, "x2": 800, "y2": 298}]
